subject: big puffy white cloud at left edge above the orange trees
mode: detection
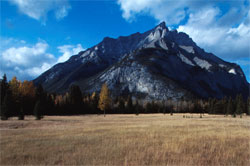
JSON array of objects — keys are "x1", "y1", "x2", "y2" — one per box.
[{"x1": 0, "y1": 39, "x2": 56, "y2": 80}]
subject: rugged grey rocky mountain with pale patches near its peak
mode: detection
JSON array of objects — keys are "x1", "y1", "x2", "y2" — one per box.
[{"x1": 34, "y1": 22, "x2": 249, "y2": 100}]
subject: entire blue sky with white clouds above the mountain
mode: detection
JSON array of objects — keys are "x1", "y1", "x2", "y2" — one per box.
[{"x1": 0, "y1": 0, "x2": 250, "y2": 81}]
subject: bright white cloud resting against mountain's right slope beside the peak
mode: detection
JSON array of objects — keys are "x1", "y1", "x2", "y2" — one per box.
[{"x1": 178, "y1": 8, "x2": 250, "y2": 60}]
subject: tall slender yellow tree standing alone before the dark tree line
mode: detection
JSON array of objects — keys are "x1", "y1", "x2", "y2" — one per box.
[{"x1": 98, "y1": 83, "x2": 111, "y2": 116}]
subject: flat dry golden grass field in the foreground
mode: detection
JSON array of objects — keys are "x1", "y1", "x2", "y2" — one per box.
[{"x1": 0, "y1": 114, "x2": 250, "y2": 166}]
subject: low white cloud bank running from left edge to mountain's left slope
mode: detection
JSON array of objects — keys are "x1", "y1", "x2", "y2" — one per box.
[{"x1": 0, "y1": 38, "x2": 84, "y2": 80}]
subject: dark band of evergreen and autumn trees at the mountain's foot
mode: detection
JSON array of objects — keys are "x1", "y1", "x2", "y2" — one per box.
[{"x1": 0, "y1": 75, "x2": 250, "y2": 120}]
